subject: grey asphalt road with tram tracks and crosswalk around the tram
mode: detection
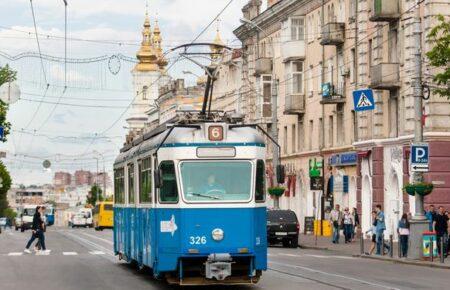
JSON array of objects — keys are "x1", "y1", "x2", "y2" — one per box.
[{"x1": 0, "y1": 228, "x2": 450, "y2": 290}]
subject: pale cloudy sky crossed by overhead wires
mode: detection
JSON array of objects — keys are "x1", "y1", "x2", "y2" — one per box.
[{"x1": 0, "y1": 0, "x2": 268, "y2": 185}]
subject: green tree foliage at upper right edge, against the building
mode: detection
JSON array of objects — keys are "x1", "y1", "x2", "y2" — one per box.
[{"x1": 426, "y1": 15, "x2": 450, "y2": 99}]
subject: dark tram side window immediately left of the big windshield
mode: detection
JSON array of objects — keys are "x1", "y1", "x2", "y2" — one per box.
[{"x1": 159, "y1": 161, "x2": 178, "y2": 203}]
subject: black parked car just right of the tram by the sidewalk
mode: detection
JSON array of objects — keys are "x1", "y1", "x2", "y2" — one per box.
[{"x1": 267, "y1": 209, "x2": 300, "y2": 248}]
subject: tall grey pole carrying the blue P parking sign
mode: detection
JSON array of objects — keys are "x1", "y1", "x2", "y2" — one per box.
[{"x1": 408, "y1": 0, "x2": 428, "y2": 259}]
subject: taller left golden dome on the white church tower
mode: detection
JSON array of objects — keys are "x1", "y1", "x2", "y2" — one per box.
[{"x1": 134, "y1": 12, "x2": 158, "y2": 71}]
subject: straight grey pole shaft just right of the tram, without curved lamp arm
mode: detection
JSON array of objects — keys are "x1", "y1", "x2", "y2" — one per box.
[{"x1": 272, "y1": 78, "x2": 280, "y2": 209}]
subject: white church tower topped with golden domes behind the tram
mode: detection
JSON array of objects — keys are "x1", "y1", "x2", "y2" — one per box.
[{"x1": 127, "y1": 7, "x2": 167, "y2": 133}]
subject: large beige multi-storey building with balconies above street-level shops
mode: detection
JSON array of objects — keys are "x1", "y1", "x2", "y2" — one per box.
[{"x1": 234, "y1": 0, "x2": 450, "y2": 233}]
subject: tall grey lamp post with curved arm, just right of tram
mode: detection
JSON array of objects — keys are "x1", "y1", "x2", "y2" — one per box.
[{"x1": 240, "y1": 18, "x2": 280, "y2": 208}]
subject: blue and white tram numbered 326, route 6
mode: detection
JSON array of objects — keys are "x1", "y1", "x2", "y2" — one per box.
[{"x1": 114, "y1": 118, "x2": 267, "y2": 285}]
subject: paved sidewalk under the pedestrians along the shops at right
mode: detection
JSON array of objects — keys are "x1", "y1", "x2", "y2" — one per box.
[{"x1": 299, "y1": 234, "x2": 450, "y2": 269}]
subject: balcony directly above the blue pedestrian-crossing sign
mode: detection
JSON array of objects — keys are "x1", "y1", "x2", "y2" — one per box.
[{"x1": 370, "y1": 63, "x2": 400, "y2": 90}]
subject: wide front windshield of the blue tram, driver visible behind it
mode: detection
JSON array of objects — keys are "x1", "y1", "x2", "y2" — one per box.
[{"x1": 180, "y1": 161, "x2": 252, "y2": 202}]
